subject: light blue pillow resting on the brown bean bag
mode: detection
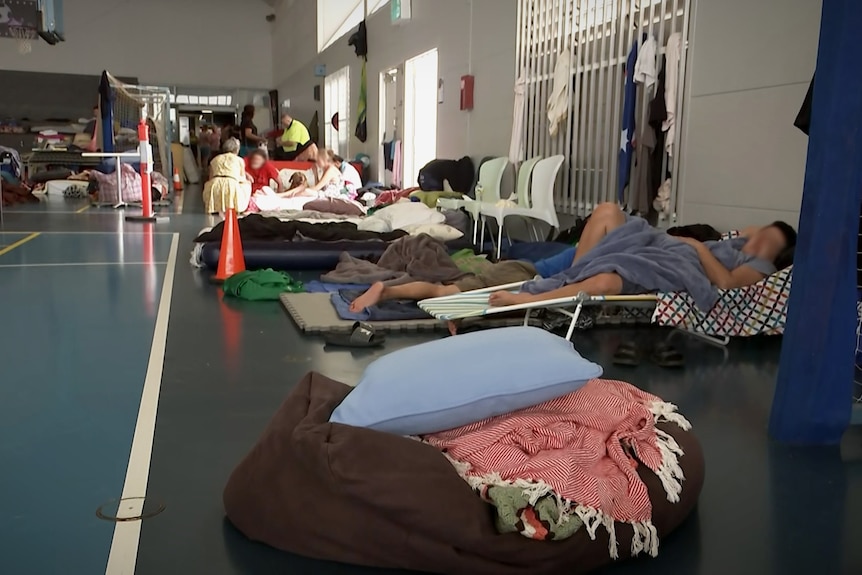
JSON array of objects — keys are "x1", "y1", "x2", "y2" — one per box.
[{"x1": 329, "y1": 327, "x2": 602, "y2": 435}]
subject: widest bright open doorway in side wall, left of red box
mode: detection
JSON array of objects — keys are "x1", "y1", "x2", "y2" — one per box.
[{"x1": 403, "y1": 48, "x2": 437, "y2": 188}]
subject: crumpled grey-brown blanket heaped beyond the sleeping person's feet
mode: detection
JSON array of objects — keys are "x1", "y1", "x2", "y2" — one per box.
[{"x1": 320, "y1": 234, "x2": 467, "y2": 285}]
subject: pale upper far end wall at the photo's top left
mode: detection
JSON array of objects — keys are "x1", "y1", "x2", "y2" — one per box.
[{"x1": 0, "y1": 0, "x2": 272, "y2": 88}]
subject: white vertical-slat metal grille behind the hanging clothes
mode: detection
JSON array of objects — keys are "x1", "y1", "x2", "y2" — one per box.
[{"x1": 515, "y1": 0, "x2": 691, "y2": 220}]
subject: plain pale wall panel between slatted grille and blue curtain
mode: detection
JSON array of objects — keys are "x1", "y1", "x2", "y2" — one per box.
[{"x1": 680, "y1": 0, "x2": 821, "y2": 229}]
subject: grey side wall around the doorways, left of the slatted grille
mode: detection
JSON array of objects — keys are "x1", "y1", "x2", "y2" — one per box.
[{"x1": 273, "y1": 0, "x2": 517, "y2": 182}]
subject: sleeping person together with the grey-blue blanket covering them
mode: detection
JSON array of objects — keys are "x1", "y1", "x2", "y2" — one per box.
[{"x1": 350, "y1": 203, "x2": 796, "y2": 312}]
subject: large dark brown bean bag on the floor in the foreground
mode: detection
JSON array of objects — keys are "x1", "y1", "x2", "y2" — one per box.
[{"x1": 224, "y1": 373, "x2": 704, "y2": 575}]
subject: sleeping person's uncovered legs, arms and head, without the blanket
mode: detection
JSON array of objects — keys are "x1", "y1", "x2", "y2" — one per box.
[{"x1": 350, "y1": 203, "x2": 796, "y2": 312}]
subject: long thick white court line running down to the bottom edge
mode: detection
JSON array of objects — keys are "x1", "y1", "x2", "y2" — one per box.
[{"x1": 105, "y1": 234, "x2": 180, "y2": 575}]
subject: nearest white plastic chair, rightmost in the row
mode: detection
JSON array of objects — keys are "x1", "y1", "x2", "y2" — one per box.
[{"x1": 480, "y1": 155, "x2": 565, "y2": 259}]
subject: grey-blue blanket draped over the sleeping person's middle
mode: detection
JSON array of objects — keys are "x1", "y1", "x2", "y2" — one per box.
[{"x1": 522, "y1": 217, "x2": 718, "y2": 311}]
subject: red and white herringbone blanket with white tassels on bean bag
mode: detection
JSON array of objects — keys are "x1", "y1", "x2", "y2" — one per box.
[{"x1": 423, "y1": 379, "x2": 691, "y2": 558}]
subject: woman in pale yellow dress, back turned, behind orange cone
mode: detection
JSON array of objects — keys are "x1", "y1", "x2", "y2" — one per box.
[{"x1": 203, "y1": 138, "x2": 251, "y2": 214}]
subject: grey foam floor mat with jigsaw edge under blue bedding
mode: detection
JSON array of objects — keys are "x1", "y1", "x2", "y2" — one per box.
[{"x1": 281, "y1": 293, "x2": 538, "y2": 334}]
